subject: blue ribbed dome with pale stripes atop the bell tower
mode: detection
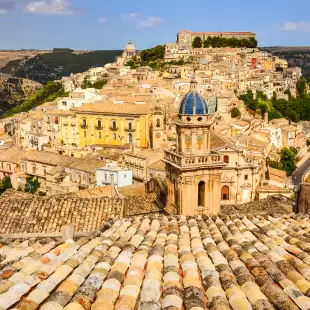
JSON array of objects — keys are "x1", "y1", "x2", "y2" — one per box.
[{"x1": 179, "y1": 91, "x2": 208, "y2": 115}]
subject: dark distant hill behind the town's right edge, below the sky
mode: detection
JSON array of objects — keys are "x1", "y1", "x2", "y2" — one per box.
[{"x1": 260, "y1": 46, "x2": 310, "y2": 79}]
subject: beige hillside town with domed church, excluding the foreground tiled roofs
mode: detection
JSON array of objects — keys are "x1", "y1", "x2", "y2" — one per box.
[{"x1": 0, "y1": 31, "x2": 310, "y2": 211}]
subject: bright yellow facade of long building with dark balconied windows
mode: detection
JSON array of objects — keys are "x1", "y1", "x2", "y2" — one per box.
[{"x1": 77, "y1": 112, "x2": 150, "y2": 148}]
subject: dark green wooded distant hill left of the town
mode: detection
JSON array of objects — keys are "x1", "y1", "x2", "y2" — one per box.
[{"x1": 0, "y1": 49, "x2": 122, "y2": 84}]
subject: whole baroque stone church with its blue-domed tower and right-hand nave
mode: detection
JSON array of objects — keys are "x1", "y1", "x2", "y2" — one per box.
[{"x1": 165, "y1": 80, "x2": 260, "y2": 215}]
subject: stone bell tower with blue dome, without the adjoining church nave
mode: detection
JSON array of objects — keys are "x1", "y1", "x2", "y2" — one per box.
[{"x1": 165, "y1": 80, "x2": 226, "y2": 215}]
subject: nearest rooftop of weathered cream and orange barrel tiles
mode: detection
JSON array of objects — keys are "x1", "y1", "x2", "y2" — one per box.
[{"x1": 0, "y1": 215, "x2": 310, "y2": 310}]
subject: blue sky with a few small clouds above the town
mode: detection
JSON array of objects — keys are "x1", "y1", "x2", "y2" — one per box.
[{"x1": 0, "y1": 0, "x2": 310, "y2": 49}]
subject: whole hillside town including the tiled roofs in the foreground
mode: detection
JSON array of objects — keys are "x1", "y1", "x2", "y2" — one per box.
[{"x1": 0, "y1": 30, "x2": 310, "y2": 310}]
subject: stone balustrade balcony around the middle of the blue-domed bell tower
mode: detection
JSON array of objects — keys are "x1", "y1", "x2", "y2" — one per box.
[{"x1": 165, "y1": 151, "x2": 227, "y2": 169}]
